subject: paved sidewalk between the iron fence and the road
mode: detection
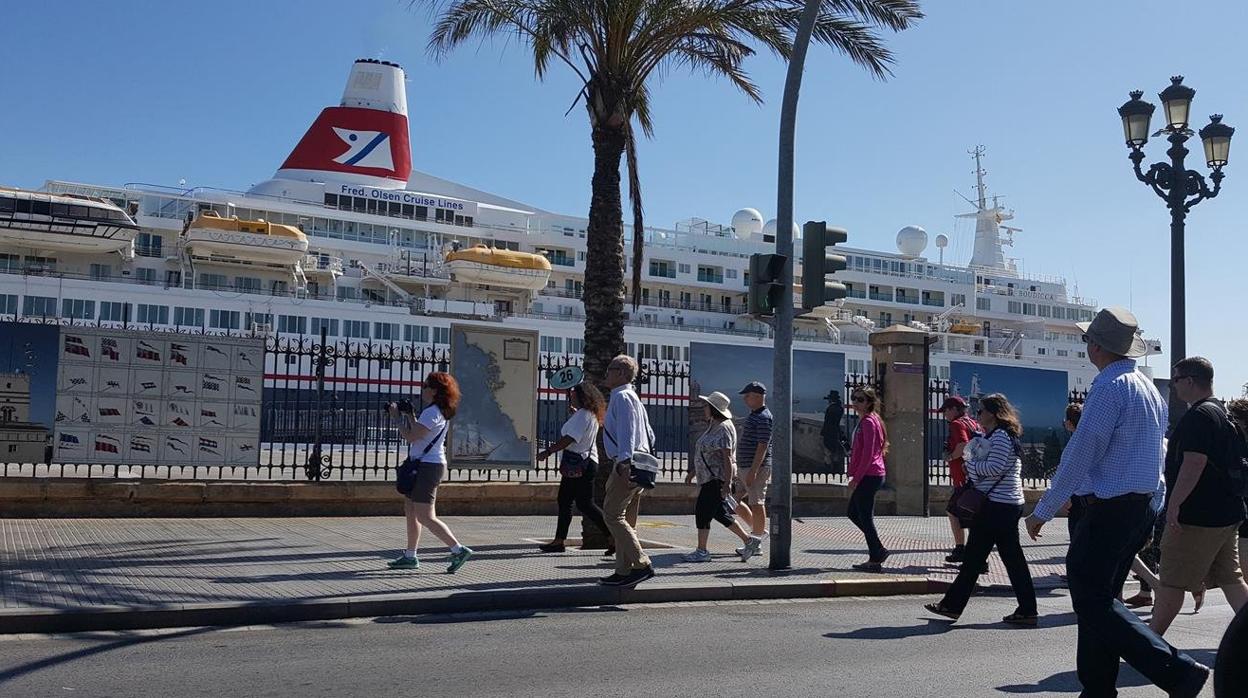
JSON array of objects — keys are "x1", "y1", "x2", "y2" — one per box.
[{"x1": 0, "y1": 516, "x2": 1067, "y2": 633}]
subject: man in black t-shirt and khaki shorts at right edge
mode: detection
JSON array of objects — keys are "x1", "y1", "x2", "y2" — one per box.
[{"x1": 1148, "y1": 356, "x2": 1248, "y2": 634}]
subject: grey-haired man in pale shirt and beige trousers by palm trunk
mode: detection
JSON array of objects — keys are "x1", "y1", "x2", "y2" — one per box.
[{"x1": 599, "y1": 355, "x2": 654, "y2": 587}]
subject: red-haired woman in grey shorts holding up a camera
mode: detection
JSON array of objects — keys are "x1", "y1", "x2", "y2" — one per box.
[{"x1": 389, "y1": 371, "x2": 473, "y2": 574}]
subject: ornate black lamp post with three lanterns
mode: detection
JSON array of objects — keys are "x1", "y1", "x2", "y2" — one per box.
[{"x1": 1118, "y1": 75, "x2": 1236, "y2": 426}]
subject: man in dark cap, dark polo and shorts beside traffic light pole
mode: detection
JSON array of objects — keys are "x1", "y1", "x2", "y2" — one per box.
[{"x1": 736, "y1": 381, "x2": 771, "y2": 557}]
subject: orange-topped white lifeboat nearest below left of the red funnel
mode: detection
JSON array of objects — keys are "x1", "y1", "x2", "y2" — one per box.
[{"x1": 182, "y1": 211, "x2": 308, "y2": 266}]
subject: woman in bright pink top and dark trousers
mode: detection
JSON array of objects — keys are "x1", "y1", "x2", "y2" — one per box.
[{"x1": 849, "y1": 387, "x2": 889, "y2": 572}]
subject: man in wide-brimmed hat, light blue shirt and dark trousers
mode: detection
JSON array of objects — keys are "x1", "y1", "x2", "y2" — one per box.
[{"x1": 1027, "y1": 307, "x2": 1209, "y2": 698}]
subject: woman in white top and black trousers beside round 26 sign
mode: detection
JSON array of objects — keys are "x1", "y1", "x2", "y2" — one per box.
[{"x1": 538, "y1": 383, "x2": 607, "y2": 553}]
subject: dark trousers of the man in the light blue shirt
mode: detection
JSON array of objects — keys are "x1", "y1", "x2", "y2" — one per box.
[{"x1": 1066, "y1": 494, "x2": 1196, "y2": 698}]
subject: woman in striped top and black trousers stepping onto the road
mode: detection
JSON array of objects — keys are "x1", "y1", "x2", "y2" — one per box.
[{"x1": 924, "y1": 393, "x2": 1036, "y2": 626}]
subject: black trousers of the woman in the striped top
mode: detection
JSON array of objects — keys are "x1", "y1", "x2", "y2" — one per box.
[{"x1": 941, "y1": 502, "x2": 1036, "y2": 616}]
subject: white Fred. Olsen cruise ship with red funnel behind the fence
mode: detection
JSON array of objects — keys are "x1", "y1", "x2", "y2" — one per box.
[{"x1": 0, "y1": 60, "x2": 1161, "y2": 397}]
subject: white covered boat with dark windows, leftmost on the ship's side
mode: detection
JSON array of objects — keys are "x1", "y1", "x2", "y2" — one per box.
[{"x1": 0, "y1": 187, "x2": 139, "y2": 255}]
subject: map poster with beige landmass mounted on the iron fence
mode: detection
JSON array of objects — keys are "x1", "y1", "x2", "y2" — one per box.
[{"x1": 447, "y1": 325, "x2": 538, "y2": 468}]
